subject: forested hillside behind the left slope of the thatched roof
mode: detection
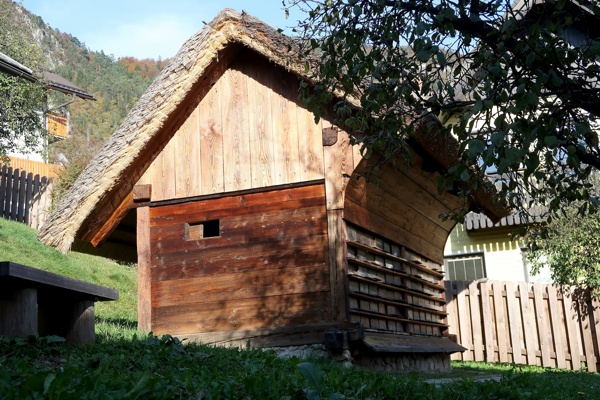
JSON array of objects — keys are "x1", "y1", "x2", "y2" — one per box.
[{"x1": 0, "y1": 0, "x2": 168, "y2": 162}]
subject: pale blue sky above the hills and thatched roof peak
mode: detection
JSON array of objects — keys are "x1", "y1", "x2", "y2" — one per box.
[{"x1": 21, "y1": 0, "x2": 302, "y2": 58}]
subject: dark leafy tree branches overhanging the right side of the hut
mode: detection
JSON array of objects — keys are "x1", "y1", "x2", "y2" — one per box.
[{"x1": 284, "y1": 0, "x2": 600, "y2": 219}]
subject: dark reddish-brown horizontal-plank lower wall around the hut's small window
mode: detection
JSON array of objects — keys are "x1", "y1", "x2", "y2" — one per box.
[{"x1": 150, "y1": 183, "x2": 332, "y2": 334}]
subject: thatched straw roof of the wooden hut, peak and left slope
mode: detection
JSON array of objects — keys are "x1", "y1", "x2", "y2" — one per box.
[{"x1": 38, "y1": 9, "x2": 506, "y2": 252}]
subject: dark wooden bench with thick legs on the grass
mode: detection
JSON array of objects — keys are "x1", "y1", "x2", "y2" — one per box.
[{"x1": 0, "y1": 261, "x2": 119, "y2": 343}]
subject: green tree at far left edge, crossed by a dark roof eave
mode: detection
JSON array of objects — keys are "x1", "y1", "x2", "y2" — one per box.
[{"x1": 0, "y1": 0, "x2": 44, "y2": 158}]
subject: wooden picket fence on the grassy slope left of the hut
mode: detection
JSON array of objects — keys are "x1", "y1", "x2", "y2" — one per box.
[{"x1": 0, "y1": 165, "x2": 52, "y2": 229}]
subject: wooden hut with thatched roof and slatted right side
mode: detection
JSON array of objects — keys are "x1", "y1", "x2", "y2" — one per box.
[{"x1": 39, "y1": 10, "x2": 501, "y2": 368}]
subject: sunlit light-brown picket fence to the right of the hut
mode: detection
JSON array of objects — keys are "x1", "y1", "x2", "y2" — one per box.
[{"x1": 445, "y1": 281, "x2": 600, "y2": 372}]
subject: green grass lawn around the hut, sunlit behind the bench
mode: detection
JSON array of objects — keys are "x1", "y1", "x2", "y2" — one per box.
[{"x1": 0, "y1": 219, "x2": 600, "y2": 400}]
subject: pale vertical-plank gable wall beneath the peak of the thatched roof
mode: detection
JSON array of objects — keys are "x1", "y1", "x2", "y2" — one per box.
[{"x1": 139, "y1": 52, "x2": 326, "y2": 201}]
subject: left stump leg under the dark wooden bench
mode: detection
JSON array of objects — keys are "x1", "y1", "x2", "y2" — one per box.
[{"x1": 0, "y1": 288, "x2": 38, "y2": 337}]
